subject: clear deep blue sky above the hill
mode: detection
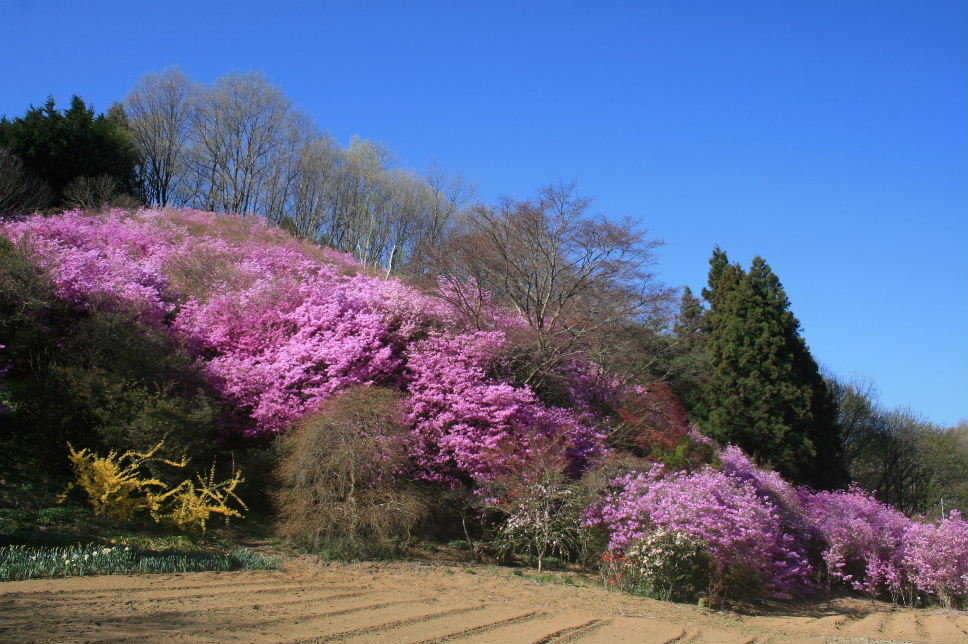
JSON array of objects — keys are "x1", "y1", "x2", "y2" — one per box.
[{"x1": 0, "y1": 0, "x2": 968, "y2": 424}]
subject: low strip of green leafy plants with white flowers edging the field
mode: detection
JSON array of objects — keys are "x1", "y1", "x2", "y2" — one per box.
[{"x1": 0, "y1": 545, "x2": 282, "y2": 581}]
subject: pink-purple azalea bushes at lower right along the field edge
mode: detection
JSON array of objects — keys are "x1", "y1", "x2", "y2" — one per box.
[{"x1": 586, "y1": 446, "x2": 968, "y2": 605}]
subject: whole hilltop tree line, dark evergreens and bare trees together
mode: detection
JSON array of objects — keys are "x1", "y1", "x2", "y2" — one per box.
[{"x1": 0, "y1": 69, "x2": 473, "y2": 270}]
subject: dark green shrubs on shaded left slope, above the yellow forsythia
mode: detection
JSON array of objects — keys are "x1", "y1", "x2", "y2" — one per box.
[{"x1": 0, "y1": 237, "x2": 224, "y2": 506}]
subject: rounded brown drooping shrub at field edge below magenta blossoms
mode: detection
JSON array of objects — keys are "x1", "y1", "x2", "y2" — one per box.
[{"x1": 275, "y1": 387, "x2": 427, "y2": 558}]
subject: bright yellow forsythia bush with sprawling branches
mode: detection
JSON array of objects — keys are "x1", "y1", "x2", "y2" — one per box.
[{"x1": 60, "y1": 441, "x2": 248, "y2": 532}]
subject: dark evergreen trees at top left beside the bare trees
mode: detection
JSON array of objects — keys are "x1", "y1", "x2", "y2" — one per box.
[{"x1": 0, "y1": 95, "x2": 138, "y2": 205}]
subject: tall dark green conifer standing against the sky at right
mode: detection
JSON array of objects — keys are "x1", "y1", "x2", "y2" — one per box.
[{"x1": 699, "y1": 247, "x2": 844, "y2": 488}]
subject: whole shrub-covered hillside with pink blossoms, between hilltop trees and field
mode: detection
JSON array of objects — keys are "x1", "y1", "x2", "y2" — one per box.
[{"x1": 0, "y1": 209, "x2": 968, "y2": 606}]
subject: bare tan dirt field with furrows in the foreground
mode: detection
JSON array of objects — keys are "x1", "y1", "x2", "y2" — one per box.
[{"x1": 0, "y1": 557, "x2": 968, "y2": 644}]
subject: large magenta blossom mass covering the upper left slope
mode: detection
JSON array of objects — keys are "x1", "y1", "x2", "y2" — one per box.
[{"x1": 4, "y1": 209, "x2": 605, "y2": 480}]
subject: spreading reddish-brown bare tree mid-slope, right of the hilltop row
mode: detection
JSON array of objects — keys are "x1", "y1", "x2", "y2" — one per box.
[{"x1": 426, "y1": 185, "x2": 672, "y2": 398}]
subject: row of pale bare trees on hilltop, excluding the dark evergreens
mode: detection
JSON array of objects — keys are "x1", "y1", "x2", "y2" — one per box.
[{"x1": 118, "y1": 69, "x2": 472, "y2": 272}]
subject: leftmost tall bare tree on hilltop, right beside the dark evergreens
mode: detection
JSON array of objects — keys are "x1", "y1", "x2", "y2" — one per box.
[{"x1": 124, "y1": 68, "x2": 197, "y2": 206}]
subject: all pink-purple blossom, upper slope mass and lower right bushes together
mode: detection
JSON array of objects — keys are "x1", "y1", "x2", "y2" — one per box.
[{"x1": 0, "y1": 209, "x2": 968, "y2": 601}]
